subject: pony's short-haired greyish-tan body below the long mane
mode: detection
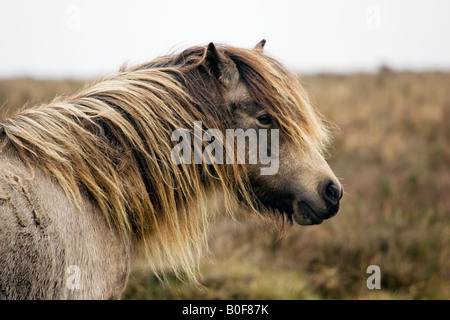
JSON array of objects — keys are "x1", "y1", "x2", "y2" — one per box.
[{"x1": 0, "y1": 148, "x2": 133, "y2": 299}]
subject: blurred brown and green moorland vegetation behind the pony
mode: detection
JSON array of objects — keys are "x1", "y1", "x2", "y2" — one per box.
[{"x1": 0, "y1": 68, "x2": 450, "y2": 299}]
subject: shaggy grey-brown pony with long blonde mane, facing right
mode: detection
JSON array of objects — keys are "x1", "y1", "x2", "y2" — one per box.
[{"x1": 0, "y1": 40, "x2": 343, "y2": 299}]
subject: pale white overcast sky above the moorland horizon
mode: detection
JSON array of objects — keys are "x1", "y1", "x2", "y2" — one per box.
[{"x1": 0, "y1": 0, "x2": 450, "y2": 78}]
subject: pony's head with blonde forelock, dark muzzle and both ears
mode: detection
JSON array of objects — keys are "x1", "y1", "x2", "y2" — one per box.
[{"x1": 191, "y1": 40, "x2": 343, "y2": 225}]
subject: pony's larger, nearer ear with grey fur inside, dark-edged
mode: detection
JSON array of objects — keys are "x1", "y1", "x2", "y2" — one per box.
[{"x1": 205, "y1": 42, "x2": 239, "y2": 89}]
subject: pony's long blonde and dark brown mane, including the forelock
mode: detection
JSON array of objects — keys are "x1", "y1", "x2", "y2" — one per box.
[{"x1": 0, "y1": 46, "x2": 328, "y2": 280}]
